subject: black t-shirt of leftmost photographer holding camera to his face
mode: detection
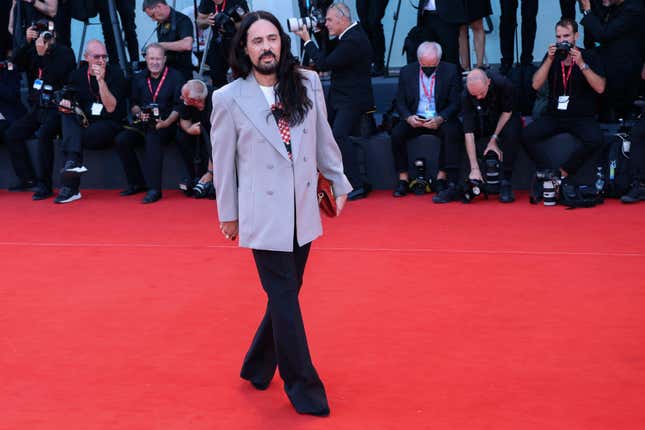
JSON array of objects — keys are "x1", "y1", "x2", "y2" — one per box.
[{"x1": 14, "y1": 42, "x2": 76, "y2": 101}]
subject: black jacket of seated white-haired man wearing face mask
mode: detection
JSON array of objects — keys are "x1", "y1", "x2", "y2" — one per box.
[{"x1": 396, "y1": 62, "x2": 461, "y2": 121}]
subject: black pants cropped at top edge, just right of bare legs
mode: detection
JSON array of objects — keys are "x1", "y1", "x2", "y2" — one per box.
[{"x1": 499, "y1": 0, "x2": 538, "y2": 66}]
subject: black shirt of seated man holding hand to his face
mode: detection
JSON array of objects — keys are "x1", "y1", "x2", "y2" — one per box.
[{"x1": 69, "y1": 61, "x2": 126, "y2": 122}]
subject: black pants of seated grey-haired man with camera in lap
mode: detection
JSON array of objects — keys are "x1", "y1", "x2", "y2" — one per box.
[{"x1": 114, "y1": 124, "x2": 177, "y2": 191}]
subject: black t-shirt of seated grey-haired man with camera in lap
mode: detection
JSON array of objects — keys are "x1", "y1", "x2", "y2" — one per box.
[{"x1": 131, "y1": 67, "x2": 184, "y2": 120}]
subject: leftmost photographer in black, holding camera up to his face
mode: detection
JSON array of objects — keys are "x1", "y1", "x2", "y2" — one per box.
[{"x1": 5, "y1": 23, "x2": 76, "y2": 200}]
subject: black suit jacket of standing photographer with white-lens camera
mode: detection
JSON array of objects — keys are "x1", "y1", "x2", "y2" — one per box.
[{"x1": 305, "y1": 24, "x2": 374, "y2": 111}]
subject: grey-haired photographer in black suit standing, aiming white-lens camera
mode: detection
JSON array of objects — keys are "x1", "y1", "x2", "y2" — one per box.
[{"x1": 295, "y1": 3, "x2": 374, "y2": 200}]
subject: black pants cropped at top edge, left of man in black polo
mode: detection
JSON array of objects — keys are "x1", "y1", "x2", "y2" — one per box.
[{"x1": 96, "y1": 0, "x2": 139, "y2": 64}]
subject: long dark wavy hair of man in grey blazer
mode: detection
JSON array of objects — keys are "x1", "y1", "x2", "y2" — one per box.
[{"x1": 229, "y1": 10, "x2": 313, "y2": 126}]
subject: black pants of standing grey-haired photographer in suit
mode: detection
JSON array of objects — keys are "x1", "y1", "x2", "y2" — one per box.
[{"x1": 328, "y1": 103, "x2": 367, "y2": 188}]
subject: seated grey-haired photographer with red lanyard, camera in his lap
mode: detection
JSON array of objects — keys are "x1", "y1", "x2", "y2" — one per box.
[{"x1": 115, "y1": 43, "x2": 183, "y2": 203}]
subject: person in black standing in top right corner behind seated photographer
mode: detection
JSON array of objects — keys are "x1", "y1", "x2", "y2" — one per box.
[{"x1": 580, "y1": 0, "x2": 645, "y2": 121}]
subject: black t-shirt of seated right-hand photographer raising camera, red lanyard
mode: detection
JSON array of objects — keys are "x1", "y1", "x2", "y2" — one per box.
[{"x1": 545, "y1": 48, "x2": 605, "y2": 118}]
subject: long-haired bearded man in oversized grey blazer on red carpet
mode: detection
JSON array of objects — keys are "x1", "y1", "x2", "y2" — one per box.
[{"x1": 211, "y1": 11, "x2": 352, "y2": 416}]
